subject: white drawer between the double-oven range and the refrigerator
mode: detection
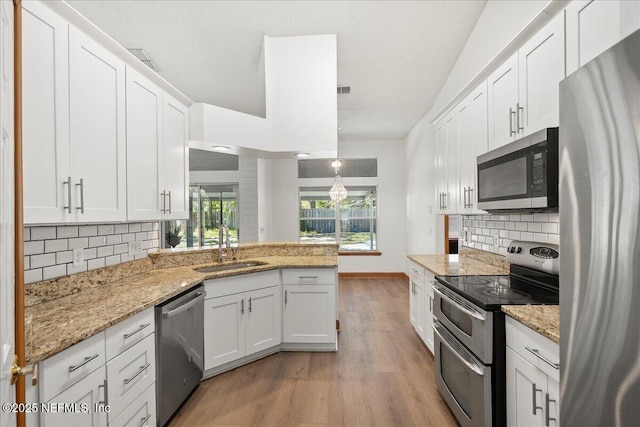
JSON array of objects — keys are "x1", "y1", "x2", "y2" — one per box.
[{"x1": 505, "y1": 316, "x2": 560, "y2": 382}]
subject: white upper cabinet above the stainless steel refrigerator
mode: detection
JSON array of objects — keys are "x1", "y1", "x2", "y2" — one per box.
[{"x1": 566, "y1": 0, "x2": 640, "y2": 75}]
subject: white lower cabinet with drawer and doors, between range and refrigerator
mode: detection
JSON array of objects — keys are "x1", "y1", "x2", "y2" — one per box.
[{"x1": 505, "y1": 317, "x2": 560, "y2": 427}]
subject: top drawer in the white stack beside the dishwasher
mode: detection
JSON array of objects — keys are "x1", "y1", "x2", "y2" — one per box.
[{"x1": 106, "y1": 307, "x2": 155, "y2": 360}]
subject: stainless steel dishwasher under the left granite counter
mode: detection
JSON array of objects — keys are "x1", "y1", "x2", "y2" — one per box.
[{"x1": 155, "y1": 285, "x2": 205, "y2": 426}]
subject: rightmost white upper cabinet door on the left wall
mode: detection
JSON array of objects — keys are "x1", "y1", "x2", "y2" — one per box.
[{"x1": 160, "y1": 92, "x2": 189, "y2": 219}]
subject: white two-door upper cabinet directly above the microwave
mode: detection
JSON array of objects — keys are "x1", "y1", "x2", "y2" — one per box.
[{"x1": 488, "y1": 12, "x2": 565, "y2": 150}]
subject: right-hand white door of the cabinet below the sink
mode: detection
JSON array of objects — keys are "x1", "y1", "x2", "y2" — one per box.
[{"x1": 246, "y1": 286, "x2": 282, "y2": 355}]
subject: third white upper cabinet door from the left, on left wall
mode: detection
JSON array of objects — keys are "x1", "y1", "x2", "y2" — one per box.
[{"x1": 126, "y1": 67, "x2": 163, "y2": 221}]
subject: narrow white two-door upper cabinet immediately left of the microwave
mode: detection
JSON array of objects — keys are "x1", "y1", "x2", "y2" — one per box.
[{"x1": 457, "y1": 81, "x2": 488, "y2": 214}]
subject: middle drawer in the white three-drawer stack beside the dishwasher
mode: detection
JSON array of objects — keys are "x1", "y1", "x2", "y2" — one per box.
[{"x1": 107, "y1": 334, "x2": 156, "y2": 417}]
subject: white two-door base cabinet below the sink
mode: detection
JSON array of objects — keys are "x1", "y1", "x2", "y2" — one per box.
[{"x1": 204, "y1": 271, "x2": 282, "y2": 371}]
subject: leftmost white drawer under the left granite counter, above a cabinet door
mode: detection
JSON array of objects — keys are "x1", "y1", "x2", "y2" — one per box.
[{"x1": 40, "y1": 332, "x2": 105, "y2": 402}]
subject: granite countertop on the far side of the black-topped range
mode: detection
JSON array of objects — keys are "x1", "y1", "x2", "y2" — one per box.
[{"x1": 407, "y1": 254, "x2": 509, "y2": 275}]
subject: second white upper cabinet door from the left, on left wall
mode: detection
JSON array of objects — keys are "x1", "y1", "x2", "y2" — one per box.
[{"x1": 69, "y1": 27, "x2": 127, "y2": 222}]
